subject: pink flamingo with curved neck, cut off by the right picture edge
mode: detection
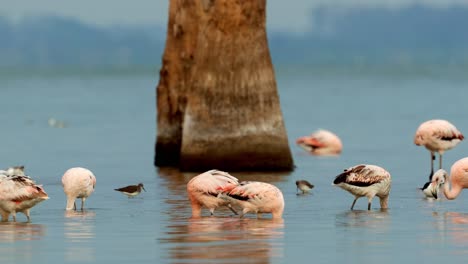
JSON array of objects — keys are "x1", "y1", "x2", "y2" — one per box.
[{"x1": 444, "y1": 157, "x2": 468, "y2": 200}]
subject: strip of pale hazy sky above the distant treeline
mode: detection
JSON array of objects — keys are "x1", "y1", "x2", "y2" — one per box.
[{"x1": 0, "y1": 0, "x2": 468, "y2": 32}]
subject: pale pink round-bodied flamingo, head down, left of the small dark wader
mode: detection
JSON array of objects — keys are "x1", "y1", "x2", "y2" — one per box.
[{"x1": 62, "y1": 167, "x2": 96, "y2": 211}]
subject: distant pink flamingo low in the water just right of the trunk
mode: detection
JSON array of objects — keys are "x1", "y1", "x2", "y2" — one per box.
[{"x1": 296, "y1": 129, "x2": 343, "y2": 156}]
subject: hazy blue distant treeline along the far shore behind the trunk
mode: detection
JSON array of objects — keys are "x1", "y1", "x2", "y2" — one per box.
[{"x1": 0, "y1": 5, "x2": 468, "y2": 68}]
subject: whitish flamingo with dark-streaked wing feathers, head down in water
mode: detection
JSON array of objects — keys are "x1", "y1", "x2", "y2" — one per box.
[{"x1": 333, "y1": 164, "x2": 392, "y2": 210}]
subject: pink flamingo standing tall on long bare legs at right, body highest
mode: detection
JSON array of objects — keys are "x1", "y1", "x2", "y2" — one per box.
[{"x1": 414, "y1": 119, "x2": 465, "y2": 180}]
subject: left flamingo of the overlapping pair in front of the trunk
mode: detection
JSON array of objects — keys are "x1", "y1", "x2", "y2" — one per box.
[{"x1": 187, "y1": 170, "x2": 239, "y2": 218}]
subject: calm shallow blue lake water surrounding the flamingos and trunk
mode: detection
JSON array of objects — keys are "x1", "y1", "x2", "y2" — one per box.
[{"x1": 0, "y1": 67, "x2": 468, "y2": 263}]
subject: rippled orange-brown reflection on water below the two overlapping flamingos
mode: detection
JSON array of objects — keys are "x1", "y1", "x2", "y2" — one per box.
[{"x1": 161, "y1": 217, "x2": 284, "y2": 263}]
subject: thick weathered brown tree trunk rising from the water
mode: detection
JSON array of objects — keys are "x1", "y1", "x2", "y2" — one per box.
[{"x1": 155, "y1": 0, "x2": 293, "y2": 171}]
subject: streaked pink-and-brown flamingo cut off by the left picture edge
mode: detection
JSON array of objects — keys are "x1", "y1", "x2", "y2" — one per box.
[{"x1": 0, "y1": 167, "x2": 49, "y2": 222}]
